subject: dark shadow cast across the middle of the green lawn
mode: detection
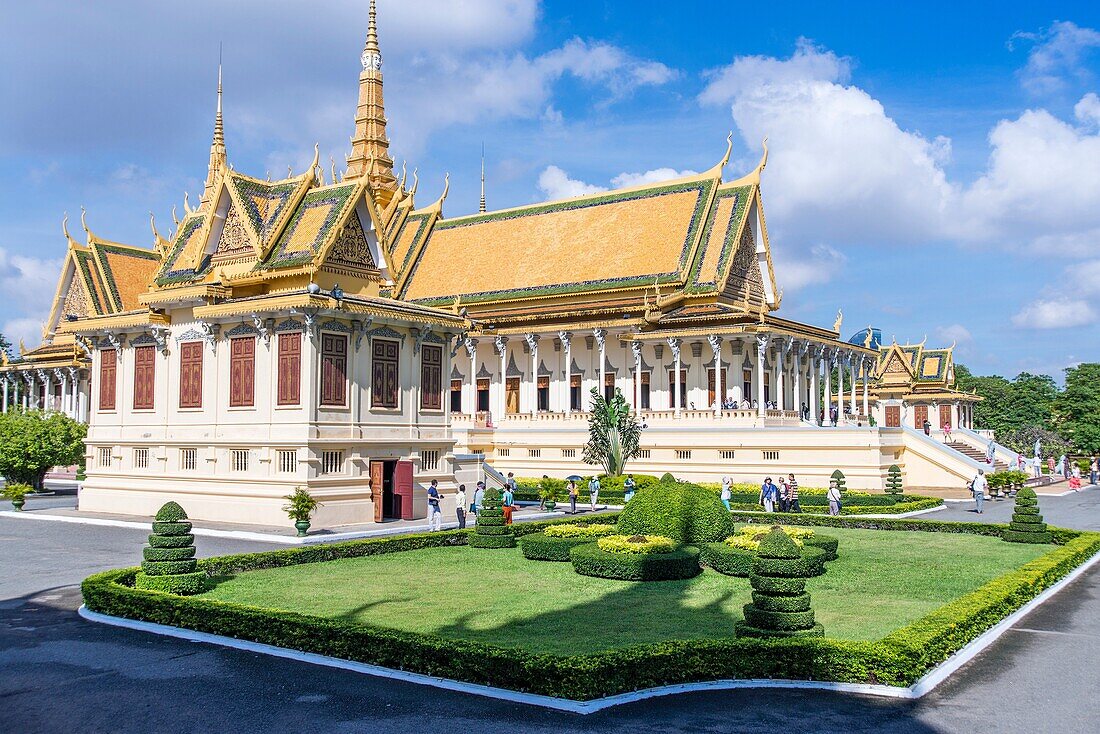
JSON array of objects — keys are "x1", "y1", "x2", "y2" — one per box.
[{"x1": 437, "y1": 577, "x2": 749, "y2": 655}]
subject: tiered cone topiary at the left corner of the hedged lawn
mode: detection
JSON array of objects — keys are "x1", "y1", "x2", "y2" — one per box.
[{"x1": 134, "y1": 502, "x2": 207, "y2": 596}]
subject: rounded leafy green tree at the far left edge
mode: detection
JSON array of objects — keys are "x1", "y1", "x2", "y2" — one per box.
[{"x1": 0, "y1": 410, "x2": 88, "y2": 489}]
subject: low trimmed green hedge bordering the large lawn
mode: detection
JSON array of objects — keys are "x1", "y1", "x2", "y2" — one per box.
[{"x1": 81, "y1": 515, "x2": 1100, "y2": 700}]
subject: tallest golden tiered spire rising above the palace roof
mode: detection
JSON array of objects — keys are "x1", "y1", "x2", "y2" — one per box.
[{"x1": 344, "y1": 0, "x2": 397, "y2": 207}]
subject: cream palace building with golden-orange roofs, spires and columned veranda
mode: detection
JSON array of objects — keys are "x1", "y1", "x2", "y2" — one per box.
[{"x1": 0, "y1": 1, "x2": 1008, "y2": 525}]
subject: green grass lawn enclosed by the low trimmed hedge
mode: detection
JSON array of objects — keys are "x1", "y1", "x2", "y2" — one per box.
[{"x1": 204, "y1": 528, "x2": 1051, "y2": 654}]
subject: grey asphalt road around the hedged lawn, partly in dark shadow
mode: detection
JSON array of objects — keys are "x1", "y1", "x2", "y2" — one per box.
[{"x1": 0, "y1": 490, "x2": 1100, "y2": 734}]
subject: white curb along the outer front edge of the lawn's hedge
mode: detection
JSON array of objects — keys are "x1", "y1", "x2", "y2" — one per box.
[{"x1": 77, "y1": 554, "x2": 1100, "y2": 714}]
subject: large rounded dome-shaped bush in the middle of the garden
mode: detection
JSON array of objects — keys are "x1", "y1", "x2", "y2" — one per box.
[{"x1": 618, "y1": 482, "x2": 734, "y2": 546}]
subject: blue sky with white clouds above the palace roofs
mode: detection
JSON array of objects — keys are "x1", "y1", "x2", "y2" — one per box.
[{"x1": 0, "y1": 0, "x2": 1100, "y2": 375}]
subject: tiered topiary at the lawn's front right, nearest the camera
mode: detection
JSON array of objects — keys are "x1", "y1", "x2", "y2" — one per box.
[{"x1": 735, "y1": 530, "x2": 825, "y2": 637}]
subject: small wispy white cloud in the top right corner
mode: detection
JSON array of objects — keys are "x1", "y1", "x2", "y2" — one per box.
[{"x1": 1009, "y1": 21, "x2": 1100, "y2": 95}]
